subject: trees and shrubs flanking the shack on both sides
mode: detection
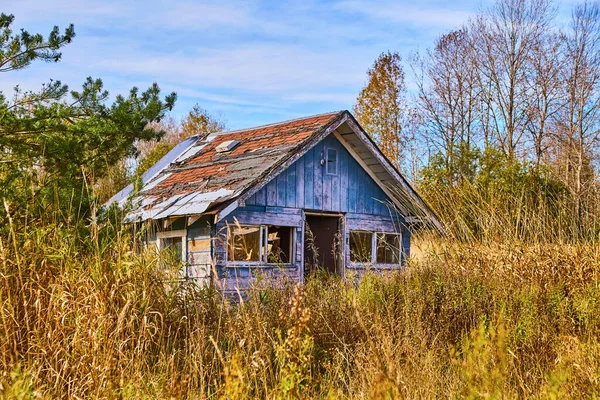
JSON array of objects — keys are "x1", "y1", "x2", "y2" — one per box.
[{"x1": 0, "y1": 0, "x2": 600, "y2": 238}]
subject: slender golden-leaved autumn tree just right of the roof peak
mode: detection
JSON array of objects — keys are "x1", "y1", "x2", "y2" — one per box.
[{"x1": 354, "y1": 51, "x2": 409, "y2": 167}]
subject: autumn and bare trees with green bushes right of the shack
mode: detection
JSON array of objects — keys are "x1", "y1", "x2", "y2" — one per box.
[{"x1": 354, "y1": 0, "x2": 600, "y2": 241}]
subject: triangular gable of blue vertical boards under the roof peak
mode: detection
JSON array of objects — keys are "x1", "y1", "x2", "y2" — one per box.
[{"x1": 246, "y1": 135, "x2": 390, "y2": 217}]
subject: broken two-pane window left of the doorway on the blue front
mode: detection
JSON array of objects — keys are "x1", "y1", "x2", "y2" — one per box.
[{"x1": 227, "y1": 225, "x2": 294, "y2": 264}]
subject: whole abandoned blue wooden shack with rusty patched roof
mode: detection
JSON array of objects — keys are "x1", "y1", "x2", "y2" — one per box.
[{"x1": 109, "y1": 111, "x2": 438, "y2": 291}]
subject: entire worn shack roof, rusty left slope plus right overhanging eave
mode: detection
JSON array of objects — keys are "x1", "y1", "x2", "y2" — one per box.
[{"x1": 108, "y1": 111, "x2": 438, "y2": 231}]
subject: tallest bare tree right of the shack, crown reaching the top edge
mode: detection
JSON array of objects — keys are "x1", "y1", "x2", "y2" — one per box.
[{"x1": 471, "y1": 0, "x2": 554, "y2": 158}]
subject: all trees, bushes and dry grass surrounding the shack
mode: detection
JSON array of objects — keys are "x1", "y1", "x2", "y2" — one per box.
[{"x1": 0, "y1": 0, "x2": 600, "y2": 399}]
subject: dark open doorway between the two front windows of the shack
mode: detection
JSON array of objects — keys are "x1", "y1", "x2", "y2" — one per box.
[{"x1": 304, "y1": 215, "x2": 340, "y2": 274}]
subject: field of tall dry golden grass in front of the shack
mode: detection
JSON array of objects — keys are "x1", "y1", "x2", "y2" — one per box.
[{"x1": 0, "y1": 208, "x2": 600, "y2": 399}]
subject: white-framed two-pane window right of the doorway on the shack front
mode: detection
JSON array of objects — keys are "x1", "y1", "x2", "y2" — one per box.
[{"x1": 349, "y1": 231, "x2": 402, "y2": 265}]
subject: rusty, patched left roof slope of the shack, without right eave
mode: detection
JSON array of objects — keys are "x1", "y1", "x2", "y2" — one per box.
[{"x1": 109, "y1": 111, "x2": 344, "y2": 221}]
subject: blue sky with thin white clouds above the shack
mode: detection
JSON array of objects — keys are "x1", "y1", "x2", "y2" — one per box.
[{"x1": 0, "y1": 0, "x2": 576, "y2": 129}]
